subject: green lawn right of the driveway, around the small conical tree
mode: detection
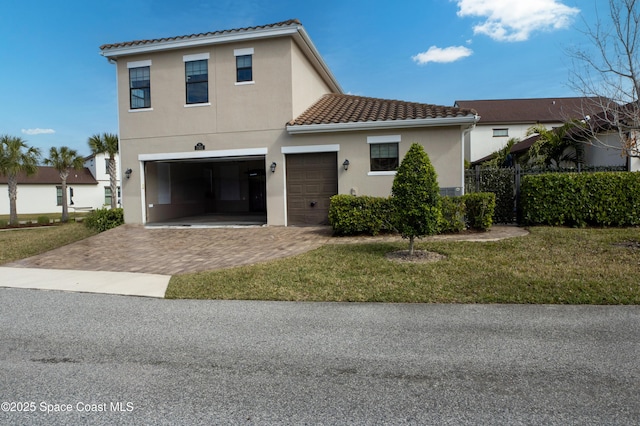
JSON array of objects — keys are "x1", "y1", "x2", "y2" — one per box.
[{"x1": 166, "y1": 227, "x2": 640, "y2": 304}]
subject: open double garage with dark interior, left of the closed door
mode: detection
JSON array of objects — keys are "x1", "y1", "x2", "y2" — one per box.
[{"x1": 144, "y1": 156, "x2": 267, "y2": 226}]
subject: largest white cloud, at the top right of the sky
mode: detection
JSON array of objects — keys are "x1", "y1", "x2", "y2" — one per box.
[{"x1": 454, "y1": 0, "x2": 580, "y2": 41}]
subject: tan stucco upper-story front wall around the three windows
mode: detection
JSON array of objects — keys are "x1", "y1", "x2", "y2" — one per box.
[{"x1": 117, "y1": 38, "x2": 298, "y2": 140}]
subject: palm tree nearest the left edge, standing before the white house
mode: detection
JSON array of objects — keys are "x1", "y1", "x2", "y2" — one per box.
[{"x1": 0, "y1": 135, "x2": 40, "y2": 225}]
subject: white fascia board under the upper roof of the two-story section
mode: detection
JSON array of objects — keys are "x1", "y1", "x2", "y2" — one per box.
[{"x1": 100, "y1": 26, "x2": 298, "y2": 58}]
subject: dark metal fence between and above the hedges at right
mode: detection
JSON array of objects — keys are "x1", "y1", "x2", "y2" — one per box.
[{"x1": 464, "y1": 165, "x2": 627, "y2": 223}]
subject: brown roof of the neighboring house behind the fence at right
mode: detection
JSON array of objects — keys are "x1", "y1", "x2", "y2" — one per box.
[{"x1": 455, "y1": 97, "x2": 594, "y2": 124}]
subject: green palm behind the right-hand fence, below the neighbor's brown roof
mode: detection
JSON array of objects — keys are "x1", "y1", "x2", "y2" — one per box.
[{"x1": 527, "y1": 121, "x2": 584, "y2": 168}]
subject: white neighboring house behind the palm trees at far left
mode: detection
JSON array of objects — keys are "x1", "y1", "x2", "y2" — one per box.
[{"x1": 0, "y1": 154, "x2": 119, "y2": 215}]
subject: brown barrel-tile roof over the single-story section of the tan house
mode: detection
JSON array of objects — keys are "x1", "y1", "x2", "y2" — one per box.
[{"x1": 288, "y1": 94, "x2": 476, "y2": 126}]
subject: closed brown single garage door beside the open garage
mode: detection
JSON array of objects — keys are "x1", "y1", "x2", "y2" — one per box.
[{"x1": 287, "y1": 152, "x2": 338, "y2": 225}]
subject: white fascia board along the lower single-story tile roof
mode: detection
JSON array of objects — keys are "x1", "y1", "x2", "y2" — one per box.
[{"x1": 287, "y1": 115, "x2": 477, "y2": 135}]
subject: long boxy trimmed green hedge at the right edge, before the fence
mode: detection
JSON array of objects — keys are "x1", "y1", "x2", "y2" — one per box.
[{"x1": 518, "y1": 172, "x2": 640, "y2": 226}]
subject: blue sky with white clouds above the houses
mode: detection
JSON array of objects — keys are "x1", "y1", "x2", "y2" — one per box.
[{"x1": 0, "y1": 0, "x2": 592, "y2": 155}]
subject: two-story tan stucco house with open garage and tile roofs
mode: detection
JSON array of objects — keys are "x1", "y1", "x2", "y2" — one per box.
[{"x1": 100, "y1": 20, "x2": 477, "y2": 225}]
